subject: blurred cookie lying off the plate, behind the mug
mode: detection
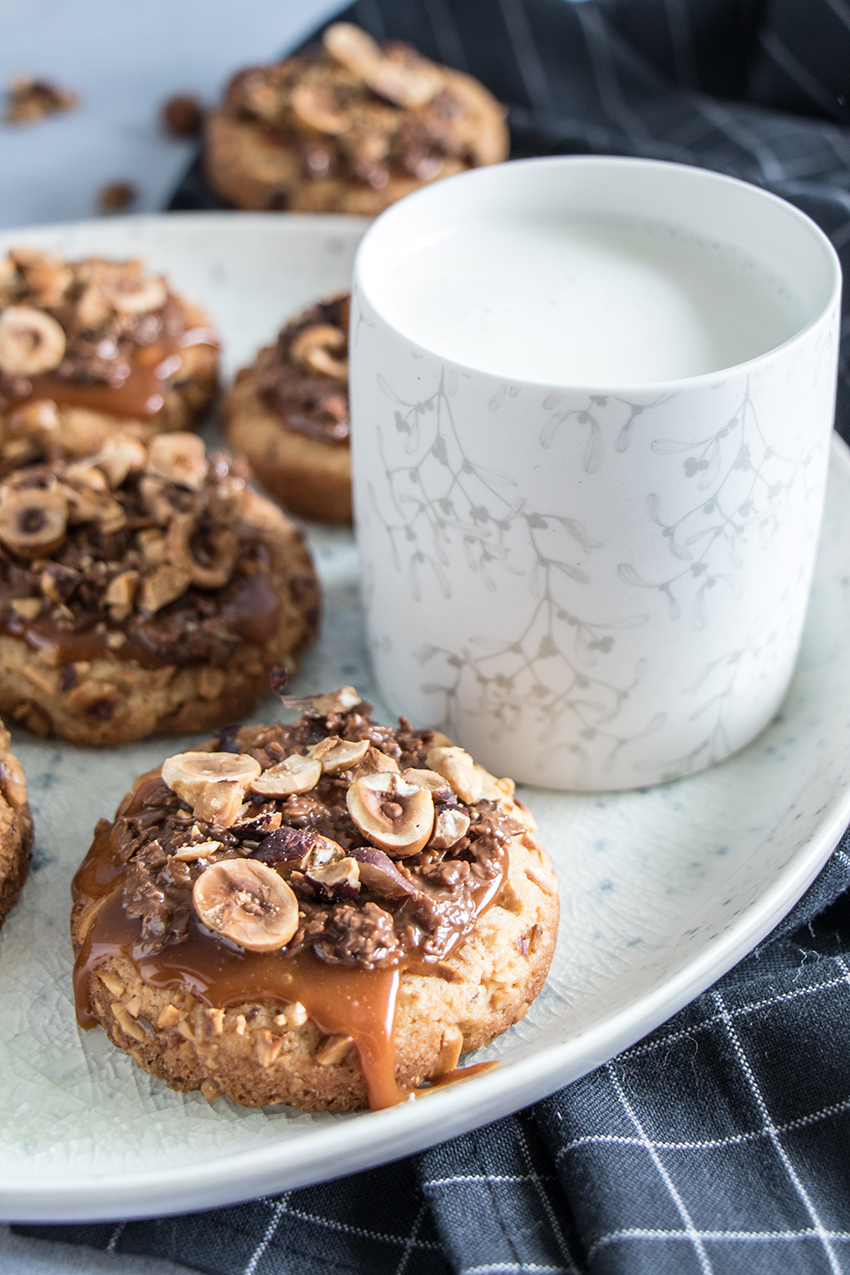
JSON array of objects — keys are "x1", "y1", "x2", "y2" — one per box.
[{"x1": 204, "y1": 23, "x2": 510, "y2": 217}]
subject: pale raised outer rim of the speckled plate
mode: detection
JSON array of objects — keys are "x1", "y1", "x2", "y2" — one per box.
[{"x1": 0, "y1": 212, "x2": 850, "y2": 1223}]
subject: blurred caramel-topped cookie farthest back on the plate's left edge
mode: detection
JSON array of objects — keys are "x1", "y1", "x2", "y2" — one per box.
[{"x1": 0, "y1": 247, "x2": 218, "y2": 473}]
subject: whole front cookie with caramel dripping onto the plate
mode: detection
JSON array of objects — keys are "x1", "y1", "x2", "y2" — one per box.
[{"x1": 71, "y1": 687, "x2": 558, "y2": 1111}]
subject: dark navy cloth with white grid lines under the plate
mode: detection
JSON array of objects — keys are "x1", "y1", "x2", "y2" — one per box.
[{"x1": 18, "y1": 0, "x2": 850, "y2": 1275}]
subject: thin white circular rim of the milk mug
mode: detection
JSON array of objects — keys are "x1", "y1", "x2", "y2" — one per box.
[{"x1": 352, "y1": 156, "x2": 842, "y2": 394}]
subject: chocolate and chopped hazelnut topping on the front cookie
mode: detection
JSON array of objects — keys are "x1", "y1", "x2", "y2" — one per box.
[{"x1": 98, "y1": 689, "x2": 526, "y2": 969}]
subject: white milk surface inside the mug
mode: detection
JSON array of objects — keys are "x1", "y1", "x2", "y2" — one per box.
[{"x1": 376, "y1": 217, "x2": 802, "y2": 388}]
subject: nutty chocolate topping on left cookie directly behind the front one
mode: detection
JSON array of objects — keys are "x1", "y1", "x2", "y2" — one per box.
[{"x1": 0, "y1": 434, "x2": 315, "y2": 668}]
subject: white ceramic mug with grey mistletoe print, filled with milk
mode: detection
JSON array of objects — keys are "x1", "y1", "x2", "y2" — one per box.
[{"x1": 350, "y1": 157, "x2": 841, "y2": 791}]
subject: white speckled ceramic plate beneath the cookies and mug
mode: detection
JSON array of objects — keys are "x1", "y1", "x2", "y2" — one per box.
[{"x1": 0, "y1": 214, "x2": 850, "y2": 1220}]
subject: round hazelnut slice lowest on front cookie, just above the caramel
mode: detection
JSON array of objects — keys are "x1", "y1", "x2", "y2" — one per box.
[{"x1": 192, "y1": 859, "x2": 298, "y2": 952}]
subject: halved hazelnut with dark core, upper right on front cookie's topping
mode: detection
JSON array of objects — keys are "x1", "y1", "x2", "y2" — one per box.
[{"x1": 345, "y1": 771, "x2": 435, "y2": 857}]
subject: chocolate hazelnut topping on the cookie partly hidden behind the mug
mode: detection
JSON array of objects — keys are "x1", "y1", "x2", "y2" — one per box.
[{"x1": 256, "y1": 293, "x2": 350, "y2": 445}]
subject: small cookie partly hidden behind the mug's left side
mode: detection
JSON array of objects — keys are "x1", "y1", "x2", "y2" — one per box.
[{"x1": 224, "y1": 293, "x2": 352, "y2": 523}]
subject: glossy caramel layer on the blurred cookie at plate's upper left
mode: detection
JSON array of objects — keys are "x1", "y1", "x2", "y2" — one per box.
[{"x1": 4, "y1": 328, "x2": 217, "y2": 419}]
